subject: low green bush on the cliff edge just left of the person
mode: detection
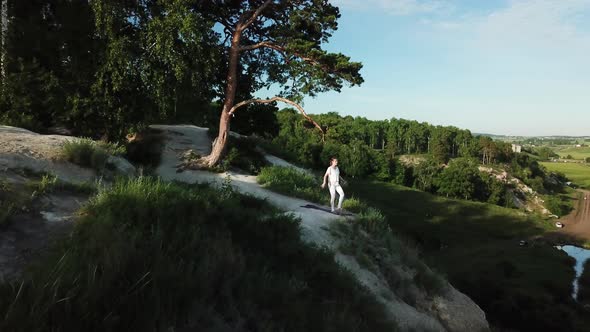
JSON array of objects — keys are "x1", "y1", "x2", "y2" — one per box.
[{"x1": 258, "y1": 166, "x2": 329, "y2": 204}]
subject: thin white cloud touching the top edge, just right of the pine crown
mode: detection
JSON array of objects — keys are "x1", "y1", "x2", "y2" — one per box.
[{"x1": 333, "y1": 0, "x2": 452, "y2": 16}]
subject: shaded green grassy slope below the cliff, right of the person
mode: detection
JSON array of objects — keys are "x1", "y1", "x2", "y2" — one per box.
[{"x1": 348, "y1": 181, "x2": 589, "y2": 331}]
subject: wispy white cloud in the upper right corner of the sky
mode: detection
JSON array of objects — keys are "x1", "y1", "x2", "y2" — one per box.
[{"x1": 421, "y1": 0, "x2": 590, "y2": 56}]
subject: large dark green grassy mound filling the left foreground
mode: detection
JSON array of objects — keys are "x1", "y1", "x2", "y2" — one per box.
[{"x1": 0, "y1": 178, "x2": 396, "y2": 332}]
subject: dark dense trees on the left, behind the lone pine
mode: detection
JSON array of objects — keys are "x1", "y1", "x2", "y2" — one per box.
[{"x1": 0, "y1": 0, "x2": 274, "y2": 140}]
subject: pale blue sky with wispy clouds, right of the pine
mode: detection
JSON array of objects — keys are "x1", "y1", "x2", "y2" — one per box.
[{"x1": 262, "y1": 0, "x2": 590, "y2": 135}]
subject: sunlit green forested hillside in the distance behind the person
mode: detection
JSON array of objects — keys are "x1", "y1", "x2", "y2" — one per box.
[{"x1": 273, "y1": 109, "x2": 557, "y2": 206}]
